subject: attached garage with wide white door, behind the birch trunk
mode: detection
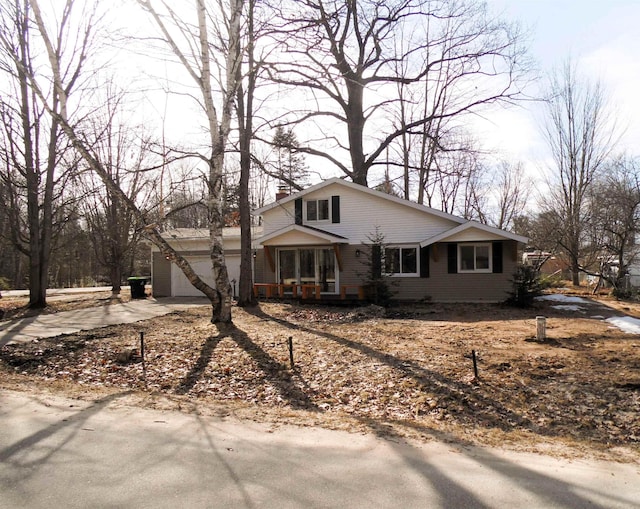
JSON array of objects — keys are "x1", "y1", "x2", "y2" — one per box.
[{"x1": 151, "y1": 228, "x2": 261, "y2": 297}]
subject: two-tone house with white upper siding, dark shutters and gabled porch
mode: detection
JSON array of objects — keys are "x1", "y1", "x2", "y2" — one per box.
[{"x1": 254, "y1": 178, "x2": 528, "y2": 302}]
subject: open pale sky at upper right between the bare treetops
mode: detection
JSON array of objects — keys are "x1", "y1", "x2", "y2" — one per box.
[{"x1": 479, "y1": 0, "x2": 640, "y2": 173}]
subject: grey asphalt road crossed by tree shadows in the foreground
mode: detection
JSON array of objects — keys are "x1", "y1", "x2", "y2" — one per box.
[{"x1": 0, "y1": 392, "x2": 640, "y2": 509}]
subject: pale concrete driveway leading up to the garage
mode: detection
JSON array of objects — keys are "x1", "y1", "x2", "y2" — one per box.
[{"x1": 0, "y1": 297, "x2": 209, "y2": 346}]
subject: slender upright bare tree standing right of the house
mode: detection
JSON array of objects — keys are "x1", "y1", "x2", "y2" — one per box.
[{"x1": 544, "y1": 61, "x2": 617, "y2": 286}]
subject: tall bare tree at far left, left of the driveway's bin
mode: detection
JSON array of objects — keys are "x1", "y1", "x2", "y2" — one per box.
[{"x1": 0, "y1": 0, "x2": 96, "y2": 308}]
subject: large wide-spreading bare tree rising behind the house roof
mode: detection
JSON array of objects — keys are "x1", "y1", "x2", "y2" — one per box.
[{"x1": 262, "y1": 0, "x2": 526, "y2": 185}]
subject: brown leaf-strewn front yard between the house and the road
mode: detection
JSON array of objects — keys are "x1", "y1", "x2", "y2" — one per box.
[{"x1": 0, "y1": 290, "x2": 640, "y2": 462}]
